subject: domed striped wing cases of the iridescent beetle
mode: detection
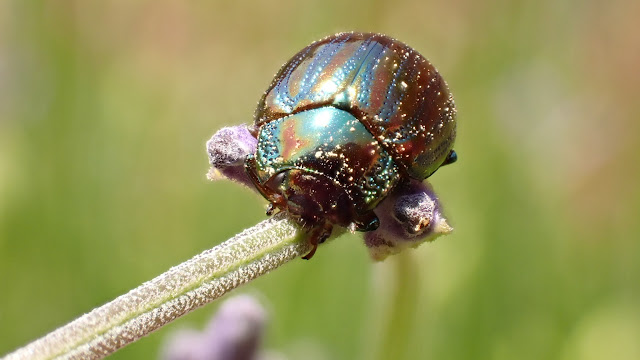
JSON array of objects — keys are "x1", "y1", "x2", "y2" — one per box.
[{"x1": 256, "y1": 33, "x2": 455, "y2": 180}]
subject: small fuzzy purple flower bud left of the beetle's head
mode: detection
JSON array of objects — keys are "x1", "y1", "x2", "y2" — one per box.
[{"x1": 207, "y1": 125, "x2": 258, "y2": 189}]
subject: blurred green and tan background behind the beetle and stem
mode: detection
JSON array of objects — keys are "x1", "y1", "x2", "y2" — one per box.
[{"x1": 0, "y1": 0, "x2": 640, "y2": 359}]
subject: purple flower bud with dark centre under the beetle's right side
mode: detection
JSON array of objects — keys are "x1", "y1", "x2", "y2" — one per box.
[{"x1": 364, "y1": 180, "x2": 453, "y2": 261}]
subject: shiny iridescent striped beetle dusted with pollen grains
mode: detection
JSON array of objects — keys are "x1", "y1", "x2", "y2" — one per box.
[{"x1": 244, "y1": 32, "x2": 457, "y2": 259}]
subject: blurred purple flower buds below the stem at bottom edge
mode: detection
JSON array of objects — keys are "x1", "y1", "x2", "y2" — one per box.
[{"x1": 163, "y1": 295, "x2": 267, "y2": 360}]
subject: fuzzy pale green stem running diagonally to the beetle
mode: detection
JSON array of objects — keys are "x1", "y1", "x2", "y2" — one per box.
[{"x1": 4, "y1": 215, "x2": 310, "y2": 360}]
